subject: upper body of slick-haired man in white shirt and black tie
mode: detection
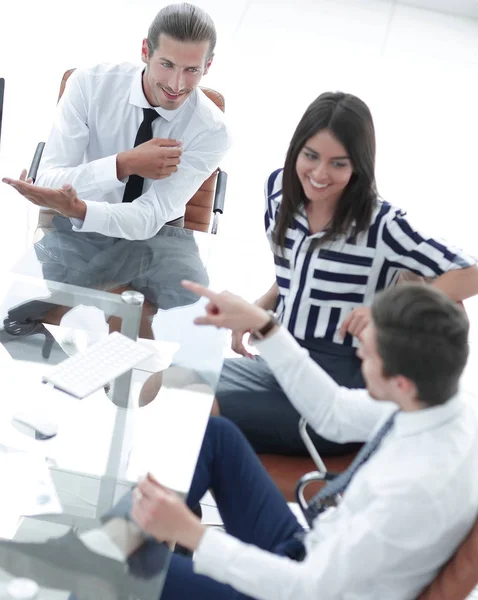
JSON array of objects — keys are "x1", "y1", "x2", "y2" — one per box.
[{"x1": 4, "y1": 3, "x2": 229, "y2": 240}]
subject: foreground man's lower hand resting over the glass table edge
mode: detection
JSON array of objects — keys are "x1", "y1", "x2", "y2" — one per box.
[{"x1": 131, "y1": 475, "x2": 205, "y2": 551}]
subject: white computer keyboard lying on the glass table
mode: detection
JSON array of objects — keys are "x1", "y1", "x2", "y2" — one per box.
[{"x1": 43, "y1": 332, "x2": 154, "y2": 398}]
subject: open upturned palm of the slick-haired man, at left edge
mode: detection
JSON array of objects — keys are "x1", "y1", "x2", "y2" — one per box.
[{"x1": 2, "y1": 169, "x2": 86, "y2": 220}]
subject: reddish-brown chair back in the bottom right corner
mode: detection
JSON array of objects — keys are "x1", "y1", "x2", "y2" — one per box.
[{"x1": 418, "y1": 521, "x2": 478, "y2": 600}]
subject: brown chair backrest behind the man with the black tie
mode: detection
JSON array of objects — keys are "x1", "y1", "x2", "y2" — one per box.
[{"x1": 58, "y1": 69, "x2": 225, "y2": 231}]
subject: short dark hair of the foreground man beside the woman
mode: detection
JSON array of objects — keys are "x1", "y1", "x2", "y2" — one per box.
[{"x1": 372, "y1": 284, "x2": 469, "y2": 406}]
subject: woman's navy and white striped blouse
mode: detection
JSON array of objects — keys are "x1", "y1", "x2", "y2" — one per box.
[{"x1": 265, "y1": 169, "x2": 476, "y2": 346}]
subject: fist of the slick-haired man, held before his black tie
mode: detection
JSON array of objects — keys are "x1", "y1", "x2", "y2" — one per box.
[{"x1": 116, "y1": 138, "x2": 183, "y2": 180}]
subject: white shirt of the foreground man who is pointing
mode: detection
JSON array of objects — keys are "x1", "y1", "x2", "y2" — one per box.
[{"x1": 194, "y1": 328, "x2": 478, "y2": 600}]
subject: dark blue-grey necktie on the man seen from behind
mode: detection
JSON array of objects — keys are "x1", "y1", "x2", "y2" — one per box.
[{"x1": 305, "y1": 410, "x2": 399, "y2": 525}]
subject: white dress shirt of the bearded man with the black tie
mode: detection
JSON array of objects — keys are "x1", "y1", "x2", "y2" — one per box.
[{"x1": 36, "y1": 63, "x2": 230, "y2": 239}]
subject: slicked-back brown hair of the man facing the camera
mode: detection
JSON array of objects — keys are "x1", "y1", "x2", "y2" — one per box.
[{"x1": 147, "y1": 2, "x2": 216, "y2": 59}]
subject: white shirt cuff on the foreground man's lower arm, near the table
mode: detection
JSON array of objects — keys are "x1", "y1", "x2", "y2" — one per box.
[{"x1": 193, "y1": 528, "x2": 243, "y2": 583}]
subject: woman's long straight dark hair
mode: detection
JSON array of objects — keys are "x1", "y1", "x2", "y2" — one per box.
[{"x1": 272, "y1": 92, "x2": 377, "y2": 253}]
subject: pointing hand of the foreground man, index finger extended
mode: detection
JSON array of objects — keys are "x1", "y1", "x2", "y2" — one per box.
[{"x1": 182, "y1": 281, "x2": 270, "y2": 331}]
